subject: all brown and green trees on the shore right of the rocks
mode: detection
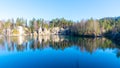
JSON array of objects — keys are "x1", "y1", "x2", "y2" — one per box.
[{"x1": 70, "y1": 17, "x2": 120, "y2": 38}]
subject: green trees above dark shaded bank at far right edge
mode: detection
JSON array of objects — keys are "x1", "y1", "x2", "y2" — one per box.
[{"x1": 99, "y1": 17, "x2": 120, "y2": 44}]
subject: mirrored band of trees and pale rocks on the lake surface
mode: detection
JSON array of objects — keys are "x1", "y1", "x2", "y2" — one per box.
[{"x1": 0, "y1": 36, "x2": 120, "y2": 56}]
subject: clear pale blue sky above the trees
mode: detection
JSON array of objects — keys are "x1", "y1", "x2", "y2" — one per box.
[{"x1": 0, "y1": 0, "x2": 120, "y2": 21}]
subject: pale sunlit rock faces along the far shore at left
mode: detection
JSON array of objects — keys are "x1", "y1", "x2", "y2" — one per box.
[{"x1": 5, "y1": 26, "x2": 68, "y2": 36}]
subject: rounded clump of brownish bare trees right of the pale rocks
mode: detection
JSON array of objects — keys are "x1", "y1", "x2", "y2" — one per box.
[{"x1": 70, "y1": 18, "x2": 101, "y2": 36}]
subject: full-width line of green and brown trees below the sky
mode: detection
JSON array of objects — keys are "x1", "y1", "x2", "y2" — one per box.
[{"x1": 0, "y1": 17, "x2": 120, "y2": 38}]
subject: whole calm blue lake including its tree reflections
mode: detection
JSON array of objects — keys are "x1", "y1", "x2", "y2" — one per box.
[{"x1": 0, "y1": 36, "x2": 120, "y2": 68}]
